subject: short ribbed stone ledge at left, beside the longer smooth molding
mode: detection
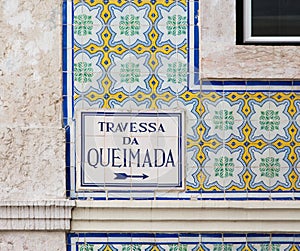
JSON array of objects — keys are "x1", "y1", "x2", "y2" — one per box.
[{"x1": 0, "y1": 200, "x2": 75, "y2": 231}]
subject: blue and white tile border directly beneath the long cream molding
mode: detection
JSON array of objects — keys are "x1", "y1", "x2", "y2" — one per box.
[{"x1": 66, "y1": 233, "x2": 300, "y2": 251}]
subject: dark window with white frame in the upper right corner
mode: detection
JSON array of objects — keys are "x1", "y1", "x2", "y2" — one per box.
[{"x1": 237, "y1": 0, "x2": 300, "y2": 43}]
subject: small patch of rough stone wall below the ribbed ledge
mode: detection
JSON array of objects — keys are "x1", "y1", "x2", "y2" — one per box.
[{"x1": 0, "y1": 231, "x2": 66, "y2": 251}]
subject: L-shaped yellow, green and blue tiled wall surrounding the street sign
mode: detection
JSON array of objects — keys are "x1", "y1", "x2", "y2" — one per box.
[{"x1": 63, "y1": 0, "x2": 300, "y2": 200}]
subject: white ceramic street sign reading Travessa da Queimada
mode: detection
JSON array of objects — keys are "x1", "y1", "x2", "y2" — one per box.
[{"x1": 76, "y1": 110, "x2": 185, "y2": 191}]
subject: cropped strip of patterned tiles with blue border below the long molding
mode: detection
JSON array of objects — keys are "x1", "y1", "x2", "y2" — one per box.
[{"x1": 67, "y1": 233, "x2": 300, "y2": 251}]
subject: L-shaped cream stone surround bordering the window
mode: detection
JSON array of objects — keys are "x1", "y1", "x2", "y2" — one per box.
[{"x1": 200, "y1": 0, "x2": 300, "y2": 79}]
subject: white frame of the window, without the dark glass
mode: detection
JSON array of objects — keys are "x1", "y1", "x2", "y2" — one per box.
[{"x1": 243, "y1": 0, "x2": 300, "y2": 43}]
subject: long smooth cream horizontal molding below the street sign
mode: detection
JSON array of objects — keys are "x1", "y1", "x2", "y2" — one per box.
[{"x1": 71, "y1": 201, "x2": 300, "y2": 233}]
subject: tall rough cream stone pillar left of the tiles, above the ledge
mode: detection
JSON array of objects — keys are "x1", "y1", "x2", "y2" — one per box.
[{"x1": 0, "y1": 0, "x2": 65, "y2": 200}]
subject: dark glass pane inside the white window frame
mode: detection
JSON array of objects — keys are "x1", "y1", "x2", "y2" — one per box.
[{"x1": 252, "y1": 0, "x2": 300, "y2": 36}]
